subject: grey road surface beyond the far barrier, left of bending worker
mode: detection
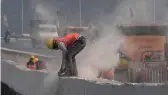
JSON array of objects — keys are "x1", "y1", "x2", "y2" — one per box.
[{"x1": 1, "y1": 40, "x2": 61, "y2": 56}]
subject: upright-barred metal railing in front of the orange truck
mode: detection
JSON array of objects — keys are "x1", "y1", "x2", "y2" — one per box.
[{"x1": 128, "y1": 61, "x2": 168, "y2": 83}]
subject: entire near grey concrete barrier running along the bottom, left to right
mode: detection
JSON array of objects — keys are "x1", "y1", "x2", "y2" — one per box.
[{"x1": 2, "y1": 61, "x2": 168, "y2": 95}]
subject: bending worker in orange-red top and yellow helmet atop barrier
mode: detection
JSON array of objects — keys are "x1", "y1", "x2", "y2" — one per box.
[{"x1": 47, "y1": 33, "x2": 86, "y2": 76}]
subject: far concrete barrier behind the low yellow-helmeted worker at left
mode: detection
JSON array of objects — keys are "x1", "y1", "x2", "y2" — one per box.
[{"x1": 1, "y1": 47, "x2": 59, "y2": 63}]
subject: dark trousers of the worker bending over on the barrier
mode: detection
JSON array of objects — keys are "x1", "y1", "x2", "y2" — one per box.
[{"x1": 59, "y1": 36, "x2": 86, "y2": 76}]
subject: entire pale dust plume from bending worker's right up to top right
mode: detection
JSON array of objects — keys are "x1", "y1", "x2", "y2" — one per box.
[{"x1": 78, "y1": 0, "x2": 167, "y2": 78}]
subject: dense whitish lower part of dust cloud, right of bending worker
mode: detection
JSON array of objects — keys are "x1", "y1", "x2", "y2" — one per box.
[{"x1": 78, "y1": 33, "x2": 122, "y2": 78}]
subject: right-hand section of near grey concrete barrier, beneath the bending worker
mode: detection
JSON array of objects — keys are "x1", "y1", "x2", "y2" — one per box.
[{"x1": 56, "y1": 78, "x2": 168, "y2": 95}]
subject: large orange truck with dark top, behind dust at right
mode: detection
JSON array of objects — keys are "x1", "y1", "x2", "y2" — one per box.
[{"x1": 115, "y1": 24, "x2": 168, "y2": 83}]
